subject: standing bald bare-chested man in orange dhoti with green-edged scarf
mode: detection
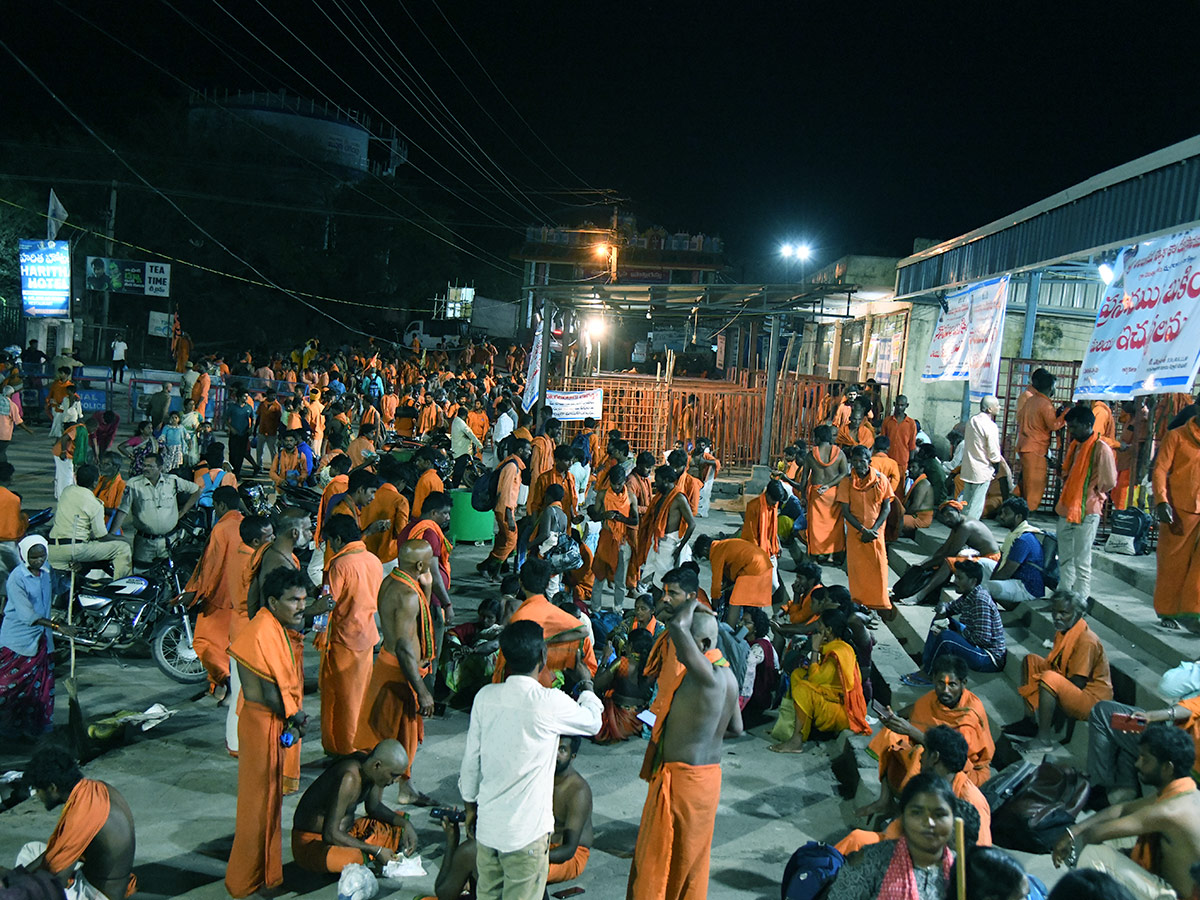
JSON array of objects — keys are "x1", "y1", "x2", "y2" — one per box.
[{"x1": 354, "y1": 540, "x2": 437, "y2": 805}]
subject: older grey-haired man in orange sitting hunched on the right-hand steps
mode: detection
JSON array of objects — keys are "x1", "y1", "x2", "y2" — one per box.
[{"x1": 1004, "y1": 590, "x2": 1112, "y2": 750}]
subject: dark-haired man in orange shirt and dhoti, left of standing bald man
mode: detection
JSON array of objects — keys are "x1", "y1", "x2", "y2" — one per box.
[{"x1": 319, "y1": 515, "x2": 383, "y2": 756}]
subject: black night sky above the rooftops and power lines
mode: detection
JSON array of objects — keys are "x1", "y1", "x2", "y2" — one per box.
[{"x1": 0, "y1": 0, "x2": 1200, "y2": 277}]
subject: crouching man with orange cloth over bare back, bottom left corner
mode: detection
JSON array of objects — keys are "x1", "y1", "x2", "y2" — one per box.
[{"x1": 17, "y1": 745, "x2": 137, "y2": 900}]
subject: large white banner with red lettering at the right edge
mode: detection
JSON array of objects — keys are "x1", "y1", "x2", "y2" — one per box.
[{"x1": 1075, "y1": 228, "x2": 1200, "y2": 400}]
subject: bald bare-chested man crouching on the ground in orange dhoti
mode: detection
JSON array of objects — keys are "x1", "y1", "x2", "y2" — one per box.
[{"x1": 292, "y1": 740, "x2": 416, "y2": 872}]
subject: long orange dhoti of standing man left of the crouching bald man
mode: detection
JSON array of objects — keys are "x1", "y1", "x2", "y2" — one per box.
[{"x1": 226, "y1": 703, "x2": 283, "y2": 898}]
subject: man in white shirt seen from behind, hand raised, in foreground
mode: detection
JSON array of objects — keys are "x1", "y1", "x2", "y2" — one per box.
[{"x1": 458, "y1": 619, "x2": 604, "y2": 900}]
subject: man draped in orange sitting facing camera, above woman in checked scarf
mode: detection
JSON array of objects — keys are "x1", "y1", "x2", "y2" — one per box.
[{"x1": 868, "y1": 654, "x2": 996, "y2": 812}]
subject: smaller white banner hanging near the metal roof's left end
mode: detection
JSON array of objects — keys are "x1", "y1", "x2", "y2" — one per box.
[{"x1": 920, "y1": 275, "x2": 1008, "y2": 400}]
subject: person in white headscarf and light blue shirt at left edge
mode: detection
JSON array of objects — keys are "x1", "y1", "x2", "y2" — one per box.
[{"x1": 0, "y1": 534, "x2": 72, "y2": 739}]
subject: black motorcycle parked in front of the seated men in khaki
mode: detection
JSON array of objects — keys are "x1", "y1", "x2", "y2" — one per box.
[{"x1": 52, "y1": 533, "x2": 208, "y2": 684}]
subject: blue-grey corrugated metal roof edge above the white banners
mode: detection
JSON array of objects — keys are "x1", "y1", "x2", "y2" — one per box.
[{"x1": 896, "y1": 137, "x2": 1200, "y2": 299}]
